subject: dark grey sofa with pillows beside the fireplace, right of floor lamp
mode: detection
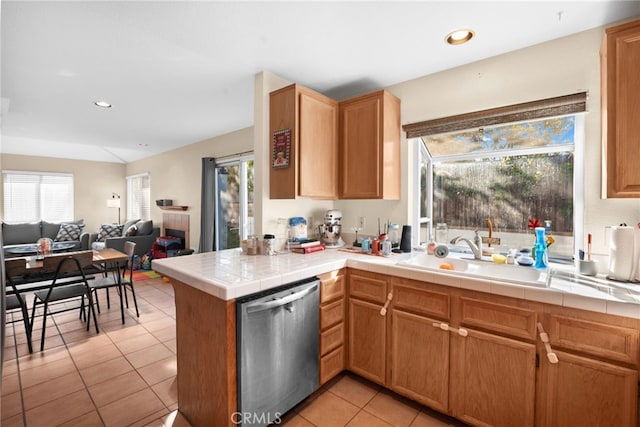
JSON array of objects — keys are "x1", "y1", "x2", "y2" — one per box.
[{"x1": 89, "y1": 219, "x2": 160, "y2": 257}]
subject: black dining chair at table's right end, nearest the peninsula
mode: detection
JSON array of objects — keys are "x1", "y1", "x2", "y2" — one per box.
[{"x1": 89, "y1": 241, "x2": 140, "y2": 324}]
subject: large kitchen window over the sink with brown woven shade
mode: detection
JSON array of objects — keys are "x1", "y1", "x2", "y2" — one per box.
[{"x1": 405, "y1": 94, "x2": 586, "y2": 257}]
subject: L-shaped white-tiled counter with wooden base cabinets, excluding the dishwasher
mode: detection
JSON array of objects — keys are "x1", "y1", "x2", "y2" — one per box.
[{"x1": 153, "y1": 250, "x2": 640, "y2": 426}]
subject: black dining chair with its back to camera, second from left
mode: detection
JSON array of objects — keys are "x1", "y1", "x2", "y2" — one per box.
[{"x1": 31, "y1": 251, "x2": 99, "y2": 351}]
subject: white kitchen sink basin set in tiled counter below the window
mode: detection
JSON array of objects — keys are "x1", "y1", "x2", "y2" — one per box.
[{"x1": 397, "y1": 254, "x2": 547, "y2": 287}]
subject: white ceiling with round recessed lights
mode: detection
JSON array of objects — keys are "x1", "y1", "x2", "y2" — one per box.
[{"x1": 0, "y1": 0, "x2": 640, "y2": 162}]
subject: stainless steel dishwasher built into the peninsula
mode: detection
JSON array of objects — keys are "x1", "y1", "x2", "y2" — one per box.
[{"x1": 233, "y1": 278, "x2": 320, "y2": 426}]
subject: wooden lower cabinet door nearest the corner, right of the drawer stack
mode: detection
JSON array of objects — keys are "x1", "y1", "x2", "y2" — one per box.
[{"x1": 348, "y1": 298, "x2": 387, "y2": 385}]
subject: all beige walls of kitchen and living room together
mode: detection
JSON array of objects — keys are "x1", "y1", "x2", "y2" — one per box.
[{"x1": 1, "y1": 20, "x2": 640, "y2": 260}]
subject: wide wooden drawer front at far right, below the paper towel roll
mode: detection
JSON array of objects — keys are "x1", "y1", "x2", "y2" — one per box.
[{"x1": 548, "y1": 315, "x2": 638, "y2": 365}]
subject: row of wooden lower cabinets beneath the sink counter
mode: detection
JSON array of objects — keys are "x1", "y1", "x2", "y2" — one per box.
[{"x1": 345, "y1": 270, "x2": 640, "y2": 427}]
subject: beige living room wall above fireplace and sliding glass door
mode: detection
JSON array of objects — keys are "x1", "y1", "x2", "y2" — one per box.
[{"x1": 126, "y1": 128, "x2": 253, "y2": 249}]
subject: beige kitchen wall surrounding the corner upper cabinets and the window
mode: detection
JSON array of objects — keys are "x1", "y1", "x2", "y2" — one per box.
[{"x1": 255, "y1": 20, "x2": 640, "y2": 255}]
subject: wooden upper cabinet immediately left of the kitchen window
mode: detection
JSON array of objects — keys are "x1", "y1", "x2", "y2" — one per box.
[{"x1": 339, "y1": 90, "x2": 400, "y2": 200}]
